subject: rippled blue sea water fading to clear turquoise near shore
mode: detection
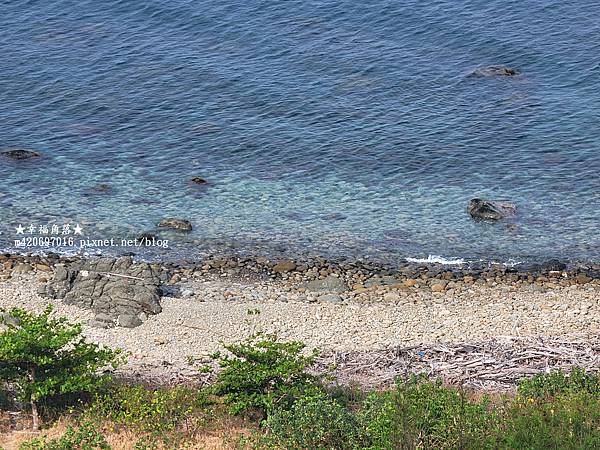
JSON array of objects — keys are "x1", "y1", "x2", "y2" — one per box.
[{"x1": 0, "y1": 0, "x2": 600, "y2": 261}]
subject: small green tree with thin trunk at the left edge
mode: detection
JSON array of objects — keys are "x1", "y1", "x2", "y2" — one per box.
[{"x1": 0, "y1": 306, "x2": 121, "y2": 431}]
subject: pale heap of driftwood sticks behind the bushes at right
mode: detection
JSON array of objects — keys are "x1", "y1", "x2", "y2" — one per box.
[{"x1": 316, "y1": 335, "x2": 600, "y2": 392}]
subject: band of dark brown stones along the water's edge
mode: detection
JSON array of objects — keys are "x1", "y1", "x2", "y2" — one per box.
[{"x1": 0, "y1": 253, "x2": 600, "y2": 293}]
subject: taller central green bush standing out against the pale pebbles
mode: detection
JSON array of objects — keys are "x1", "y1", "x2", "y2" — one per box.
[{"x1": 213, "y1": 333, "x2": 319, "y2": 417}]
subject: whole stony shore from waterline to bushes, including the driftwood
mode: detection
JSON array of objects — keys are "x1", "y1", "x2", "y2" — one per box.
[{"x1": 0, "y1": 255, "x2": 600, "y2": 391}]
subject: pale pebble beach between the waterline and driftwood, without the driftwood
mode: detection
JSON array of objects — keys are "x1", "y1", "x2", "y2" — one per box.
[{"x1": 0, "y1": 256, "x2": 600, "y2": 390}]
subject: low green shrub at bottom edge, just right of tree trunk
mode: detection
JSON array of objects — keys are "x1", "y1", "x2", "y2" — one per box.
[{"x1": 19, "y1": 422, "x2": 110, "y2": 450}]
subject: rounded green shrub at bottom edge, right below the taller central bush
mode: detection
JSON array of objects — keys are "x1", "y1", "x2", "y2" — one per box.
[{"x1": 265, "y1": 392, "x2": 363, "y2": 450}]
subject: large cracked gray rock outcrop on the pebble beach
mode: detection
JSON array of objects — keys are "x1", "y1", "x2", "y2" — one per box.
[{"x1": 46, "y1": 257, "x2": 169, "y2": 328}]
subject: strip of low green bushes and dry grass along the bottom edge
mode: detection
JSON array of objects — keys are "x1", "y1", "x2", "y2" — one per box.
[{"x1": 0, "y1": 370, "x2": 600, "y2": 450}]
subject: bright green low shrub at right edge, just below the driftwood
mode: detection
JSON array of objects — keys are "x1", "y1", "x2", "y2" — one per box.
[{"x1": 519, "y1": 368, "x2": 600, "y2": 398}]
